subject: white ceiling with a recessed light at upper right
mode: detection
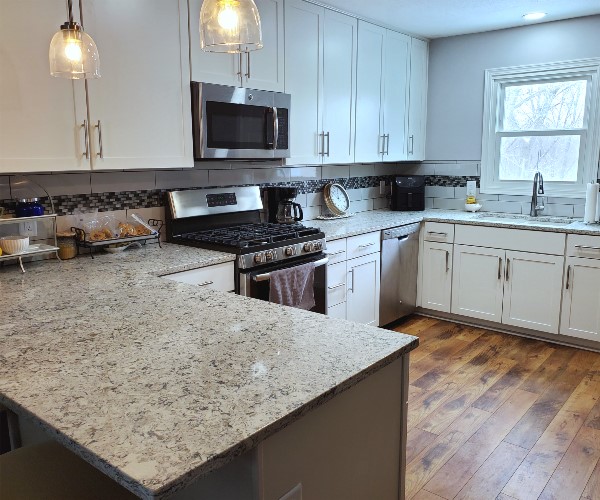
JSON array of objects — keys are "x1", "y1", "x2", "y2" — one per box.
[{"x1": 322, "y1": 0, "x2": 600, "y2": 38}]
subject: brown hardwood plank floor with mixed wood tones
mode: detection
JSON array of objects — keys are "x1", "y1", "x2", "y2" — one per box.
[{"x1": 396, "y1": 316, "x2": 600, "y2": 500}]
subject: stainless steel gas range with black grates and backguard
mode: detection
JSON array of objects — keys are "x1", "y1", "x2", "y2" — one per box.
[{"x1": 166, "y1": 186, "x2": 328, "y2": 314}]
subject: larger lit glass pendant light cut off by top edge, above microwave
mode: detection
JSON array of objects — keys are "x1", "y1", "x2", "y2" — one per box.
[{"x1": 200, "y1": 0, "x2": 263, "y2": 54}]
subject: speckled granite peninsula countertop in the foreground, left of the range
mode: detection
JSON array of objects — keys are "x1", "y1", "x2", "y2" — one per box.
[{"x1": 0, "y1": 244, "x2": 418, "y2": 498}]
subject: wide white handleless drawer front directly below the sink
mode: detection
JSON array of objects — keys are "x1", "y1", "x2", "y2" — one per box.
[{"x1": 454, "y1": 224, "x2": 565, "y2": 255}]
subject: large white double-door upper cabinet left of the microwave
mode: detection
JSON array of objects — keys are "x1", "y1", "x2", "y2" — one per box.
[{"x1": 0, "y1": 0, "x2": 193, "y2": 172}]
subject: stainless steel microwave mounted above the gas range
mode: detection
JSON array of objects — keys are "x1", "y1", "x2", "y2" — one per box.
[{"x1": 192, "y1": 82, "x2": 292, "y2": 160}]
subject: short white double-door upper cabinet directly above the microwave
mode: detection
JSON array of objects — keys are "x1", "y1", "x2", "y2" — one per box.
[{"x1": 189, "y1": 0, "x2": 284, "y2": 92}]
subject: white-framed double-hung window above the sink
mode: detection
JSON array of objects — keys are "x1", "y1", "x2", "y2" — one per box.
[{"x1": 481, "y1": 59, "x2": 600, "y2": 198}]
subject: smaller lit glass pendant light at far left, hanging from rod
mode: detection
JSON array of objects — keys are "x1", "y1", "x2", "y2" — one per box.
[{"x1": 48, "y1": 0, "x2": 100, "y2": 80}]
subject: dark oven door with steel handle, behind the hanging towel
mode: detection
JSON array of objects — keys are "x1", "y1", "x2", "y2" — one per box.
[{"x1": 238, "y1": 254, "x2": 329, "y2": 314}]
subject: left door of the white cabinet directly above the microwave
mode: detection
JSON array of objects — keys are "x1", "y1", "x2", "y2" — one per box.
[{"x1": 188, "y1": 0, "x2": 241, "y2": 87}]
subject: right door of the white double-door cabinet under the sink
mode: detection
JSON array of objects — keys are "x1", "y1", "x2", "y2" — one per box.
[{"x1": 502, "y1": 251, "x2": 565, "y2": 333}]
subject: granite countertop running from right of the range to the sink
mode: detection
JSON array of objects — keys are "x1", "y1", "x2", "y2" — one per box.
[{"x1": 310, "y1": 209, "x2": 600, "y2": 241}]
